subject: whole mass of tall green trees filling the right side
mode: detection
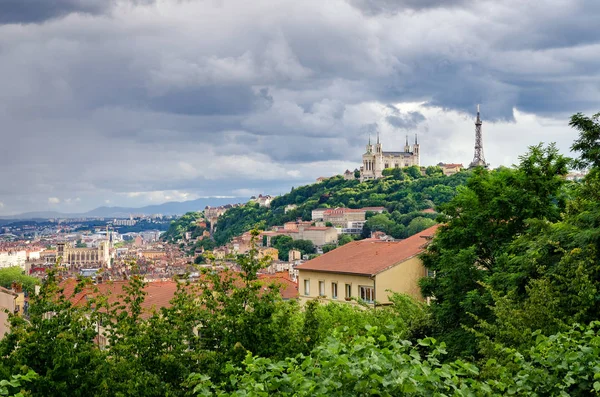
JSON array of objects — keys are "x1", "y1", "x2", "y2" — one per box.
[{"x1": 422, "y1": 115, "x2": 600, "y2": 357}]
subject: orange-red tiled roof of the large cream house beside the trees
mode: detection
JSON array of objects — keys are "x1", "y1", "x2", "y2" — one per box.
[{"x1": 297, "y1": 225, "x2": 439, "y2": 276}]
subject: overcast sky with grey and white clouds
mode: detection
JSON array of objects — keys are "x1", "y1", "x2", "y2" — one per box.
[{"x1": 0, "y1": 0, "x2": 600, "y2": 215}]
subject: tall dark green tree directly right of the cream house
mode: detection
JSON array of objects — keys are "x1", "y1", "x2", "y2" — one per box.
[{"x1": 421, "y1": 145, "x2": 568, "y2": 355}]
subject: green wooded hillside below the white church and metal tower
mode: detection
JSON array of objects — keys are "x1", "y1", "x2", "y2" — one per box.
[{"x1": 214, "y1": 167, "x2": 470, "y2": 245}]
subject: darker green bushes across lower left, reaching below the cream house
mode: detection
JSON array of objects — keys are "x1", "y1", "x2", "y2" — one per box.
[{"x1": 0, "y1": 234, "x2": 427, "y2": 396}]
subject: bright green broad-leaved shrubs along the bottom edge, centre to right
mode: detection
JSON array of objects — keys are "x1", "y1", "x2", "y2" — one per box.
[{"x1": 191, "y1": 322, "x2": 600, "y2": 397}]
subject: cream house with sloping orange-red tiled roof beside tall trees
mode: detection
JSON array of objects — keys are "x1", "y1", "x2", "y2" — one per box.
[{"x1": 296, "y1": 225, "x2": 438, "y2": 305}]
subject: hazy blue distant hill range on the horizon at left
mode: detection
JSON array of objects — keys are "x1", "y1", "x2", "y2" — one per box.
[{"x1": 0, "y1": 197, "x2": 249, "y2": 220}]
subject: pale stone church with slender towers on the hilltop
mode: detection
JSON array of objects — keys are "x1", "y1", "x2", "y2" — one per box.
[{"x1": 360, "y1": 133, "x2": 421, "y2": 182}]
